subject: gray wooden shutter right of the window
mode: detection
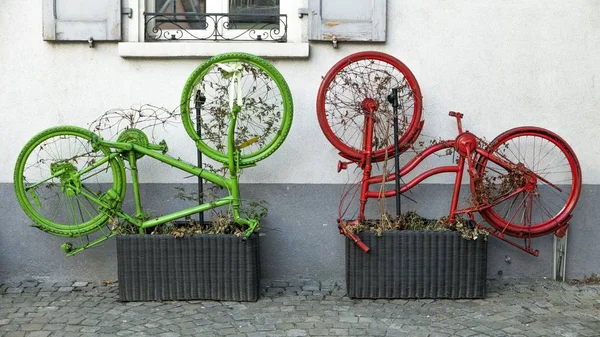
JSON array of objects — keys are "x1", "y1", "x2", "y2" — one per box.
[{"x1": 308, "y1": 0, "x2": 386, "y2": 41}]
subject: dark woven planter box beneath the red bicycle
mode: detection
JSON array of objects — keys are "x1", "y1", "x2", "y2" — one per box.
[{"x1": 346, "y1": 231, "x2": 487, "y2": 299}]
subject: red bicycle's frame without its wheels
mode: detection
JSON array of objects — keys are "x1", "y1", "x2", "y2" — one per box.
[{"x1": 338, "y1": 110, "x2": 543, "y2": 256}]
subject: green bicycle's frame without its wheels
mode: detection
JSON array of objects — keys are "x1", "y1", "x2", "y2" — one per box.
[{"x1": 62, "y1": 105, "x2": 258, "y2": 256}]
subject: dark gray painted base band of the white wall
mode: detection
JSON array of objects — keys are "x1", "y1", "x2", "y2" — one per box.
[{"x1": 0, "y1": 183, "x2": 600, "y2": 282}]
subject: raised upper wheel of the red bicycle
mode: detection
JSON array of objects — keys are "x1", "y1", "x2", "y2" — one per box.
[{"x1": 317, "y1": 51, "x2": 422, "y2": 161}]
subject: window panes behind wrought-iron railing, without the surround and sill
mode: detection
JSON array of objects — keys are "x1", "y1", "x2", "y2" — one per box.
[{"x1": 144, "y1": 0, "x2": 287, "y2": 42}]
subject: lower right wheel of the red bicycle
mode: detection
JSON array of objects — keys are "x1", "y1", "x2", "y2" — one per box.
[{"x1": 476, "y1": 126, "x2": 581, "y2": 237}]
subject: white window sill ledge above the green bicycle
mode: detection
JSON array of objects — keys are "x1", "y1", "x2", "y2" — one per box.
[{"x1": 119, "y1": 42, "x2": 309, "y2": 58}]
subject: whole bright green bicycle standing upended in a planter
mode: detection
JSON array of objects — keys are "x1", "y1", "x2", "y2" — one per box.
[{"x1": 14, "y1": 53, "x2": 293, "y2": 256}]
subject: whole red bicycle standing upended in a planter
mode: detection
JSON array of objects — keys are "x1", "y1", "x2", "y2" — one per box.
[{"x1": 317, "y1": 51, "x2": 581, "y2": 256}]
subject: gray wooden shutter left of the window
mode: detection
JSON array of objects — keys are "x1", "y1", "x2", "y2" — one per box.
[{"x1": 42, "y1": 0, "x2": 121, "y2": 41}]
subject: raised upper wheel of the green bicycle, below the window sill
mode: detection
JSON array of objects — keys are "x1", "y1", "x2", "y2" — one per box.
[{"x1": 181, "y1": 53, "x2": 293, "y2": 166}]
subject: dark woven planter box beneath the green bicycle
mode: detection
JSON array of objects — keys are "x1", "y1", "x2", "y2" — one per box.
[{"x1": 117, "y1": 234, "x2": 260, "y2": 301}]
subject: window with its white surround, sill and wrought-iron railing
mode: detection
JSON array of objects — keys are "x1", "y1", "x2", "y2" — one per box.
[{"x1": 119, "y1": 0, "x2": 309, "y2": 58}]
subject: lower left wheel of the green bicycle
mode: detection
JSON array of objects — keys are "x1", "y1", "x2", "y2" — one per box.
[{"x1": 14, "y1": 126, "x2": 126, "y2": 237}]
